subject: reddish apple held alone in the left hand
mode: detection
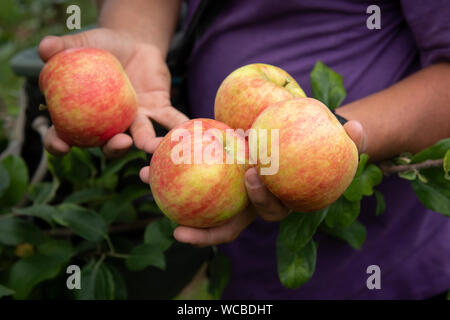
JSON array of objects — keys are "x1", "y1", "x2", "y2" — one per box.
[{"x1": 39, "y1": 48, "x2": 137, "y2": 147}]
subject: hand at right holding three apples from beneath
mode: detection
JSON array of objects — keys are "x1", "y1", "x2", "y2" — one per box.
[{"x1": 140, "y1": 120, "x2": 367, "y2": 247}]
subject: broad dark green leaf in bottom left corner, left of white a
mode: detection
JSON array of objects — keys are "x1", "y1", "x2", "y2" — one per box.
[{"x1": 8, "y1": 254, "x2": 66, "y2": 299}]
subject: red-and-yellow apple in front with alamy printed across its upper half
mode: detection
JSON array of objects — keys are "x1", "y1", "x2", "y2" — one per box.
[{"x1": 149, "y1": 119, "x2": 248, "y2": 228}]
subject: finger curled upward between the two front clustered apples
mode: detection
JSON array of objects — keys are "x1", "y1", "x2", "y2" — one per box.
[{"x1": 245, "y1": 168, "x2": 289, "y2": 221}]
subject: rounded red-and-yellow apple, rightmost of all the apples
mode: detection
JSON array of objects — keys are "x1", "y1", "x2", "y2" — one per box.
[{"x1": 252, "y1": 98, "x2": 358, "y2": 212}]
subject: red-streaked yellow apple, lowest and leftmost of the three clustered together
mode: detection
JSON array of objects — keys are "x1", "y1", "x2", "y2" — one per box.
[{"x1": 149, "y1": 119, "x2": 248, "y2": 228}]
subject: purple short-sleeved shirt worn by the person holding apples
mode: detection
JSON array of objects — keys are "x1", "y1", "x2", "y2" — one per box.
[{"x1": 184, "y1": 0, "x2": 450, "y2": 299}]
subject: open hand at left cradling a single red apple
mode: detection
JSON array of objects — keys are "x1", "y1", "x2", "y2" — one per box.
[{"x1": 39, "y1": 28, "x2": 188, "y2": 157}]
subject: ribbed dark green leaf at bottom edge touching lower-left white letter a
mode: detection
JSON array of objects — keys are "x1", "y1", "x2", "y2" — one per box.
[{"x1": 75, "y1": 260, "x2": 115, "y2": 300}]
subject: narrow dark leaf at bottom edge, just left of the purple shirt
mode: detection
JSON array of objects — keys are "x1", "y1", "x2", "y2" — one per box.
[{"x1": 208, "y1": 253, "x2": 231, "y2": 300}]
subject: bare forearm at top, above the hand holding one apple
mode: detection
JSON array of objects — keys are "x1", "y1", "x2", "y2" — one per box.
[{"x1": 99, "y1": 0, "x2": 181, "y2": 57}]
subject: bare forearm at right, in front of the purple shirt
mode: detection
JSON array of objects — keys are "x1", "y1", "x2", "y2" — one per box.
[{"x1": 337, "y1": 63, "x2": 450, "y2": 161}]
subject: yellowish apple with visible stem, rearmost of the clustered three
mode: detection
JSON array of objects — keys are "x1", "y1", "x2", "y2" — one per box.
[{"x1": 214, "y1": 63, "x2": 306, "y2": 131}]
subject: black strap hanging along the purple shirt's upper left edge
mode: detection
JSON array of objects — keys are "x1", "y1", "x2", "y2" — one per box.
[{"x1": 167, "y1": 0, "x2": 228, "y2": 75}]
